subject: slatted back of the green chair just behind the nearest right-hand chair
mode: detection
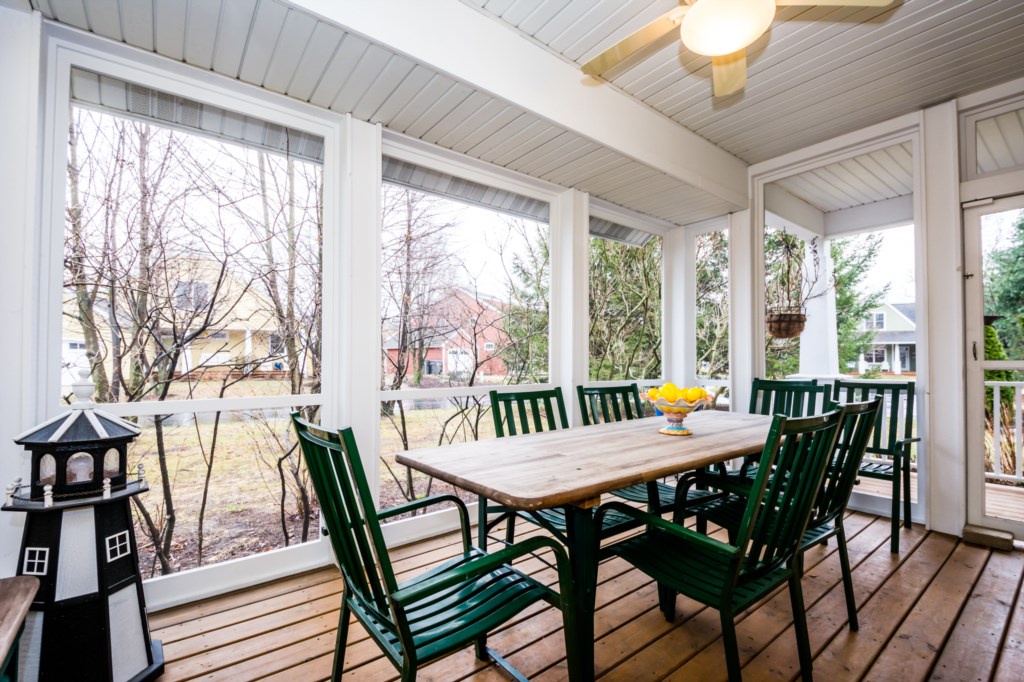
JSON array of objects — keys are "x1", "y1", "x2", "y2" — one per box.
[{"x1": 807, "y1": 397, "x2": 882, "y2": 527}]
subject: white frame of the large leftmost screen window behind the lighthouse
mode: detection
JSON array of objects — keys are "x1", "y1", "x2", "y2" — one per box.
[{"x1": 37, "y1": 25, "x2": 357, "y2": 608}]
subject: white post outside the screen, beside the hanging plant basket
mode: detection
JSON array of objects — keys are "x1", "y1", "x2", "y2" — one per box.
[{"x1": 800, "y1": 237, "x2": 840, "y2": 377}]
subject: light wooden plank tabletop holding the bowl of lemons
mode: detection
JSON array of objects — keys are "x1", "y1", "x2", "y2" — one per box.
[{"x1": 396, "y1": 412, "x2": 771, "y2": 509}]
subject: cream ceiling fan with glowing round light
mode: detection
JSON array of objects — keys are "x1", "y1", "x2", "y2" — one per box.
[{"x1": 583, "y1": 0, "x2": 893, "y2": 97}]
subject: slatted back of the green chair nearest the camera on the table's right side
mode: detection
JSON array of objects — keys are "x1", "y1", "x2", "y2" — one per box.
[{"x1": 736, "y1": 410, "x2": 844, "y2": 574}]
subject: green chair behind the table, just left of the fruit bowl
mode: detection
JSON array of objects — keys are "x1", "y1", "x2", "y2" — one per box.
[{"x1": 577, "y1": 383, "x2": 708, "y2": 514}]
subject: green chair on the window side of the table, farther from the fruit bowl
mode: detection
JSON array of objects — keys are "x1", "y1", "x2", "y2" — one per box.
[{"x1": 477, "y1": 386, "x2": 646, "y2": 550}]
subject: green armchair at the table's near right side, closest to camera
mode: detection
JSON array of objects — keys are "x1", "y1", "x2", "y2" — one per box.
[{"x1": 598, "y1": 410, "x2": 844, "y2": 682}]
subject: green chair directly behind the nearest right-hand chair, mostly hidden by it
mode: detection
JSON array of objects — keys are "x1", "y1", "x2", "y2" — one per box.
[{"x1": 676, "y1": 398, "x2": 882, "y2": 631}]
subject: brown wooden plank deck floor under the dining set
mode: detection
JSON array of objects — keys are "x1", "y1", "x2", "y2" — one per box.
[{"x1": 151, "y1": 513, "x2": 1024, "y2": 682}]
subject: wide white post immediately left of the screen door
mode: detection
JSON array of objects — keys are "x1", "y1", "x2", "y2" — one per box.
[{"x1": 914, "y1": 101, "x2": 968, "y2": 535}]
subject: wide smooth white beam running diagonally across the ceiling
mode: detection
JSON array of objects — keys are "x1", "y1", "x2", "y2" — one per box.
[{"x1": 291, "y1": 0, "x2": 748, "y2": 209}]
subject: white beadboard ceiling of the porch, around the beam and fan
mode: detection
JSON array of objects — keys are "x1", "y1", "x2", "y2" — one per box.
[{"x1": 32, "y1": 0, "x2": 1024, "y2": 224}]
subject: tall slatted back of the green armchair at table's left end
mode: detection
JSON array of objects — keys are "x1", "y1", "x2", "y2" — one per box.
[{"x1": 292, "y1": 414, "x2": 396, "y2": 624}]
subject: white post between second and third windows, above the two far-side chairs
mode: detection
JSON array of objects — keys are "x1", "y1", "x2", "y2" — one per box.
[{"x1": 549, "y1": 189, "x2": 590, "y2": 425}]
